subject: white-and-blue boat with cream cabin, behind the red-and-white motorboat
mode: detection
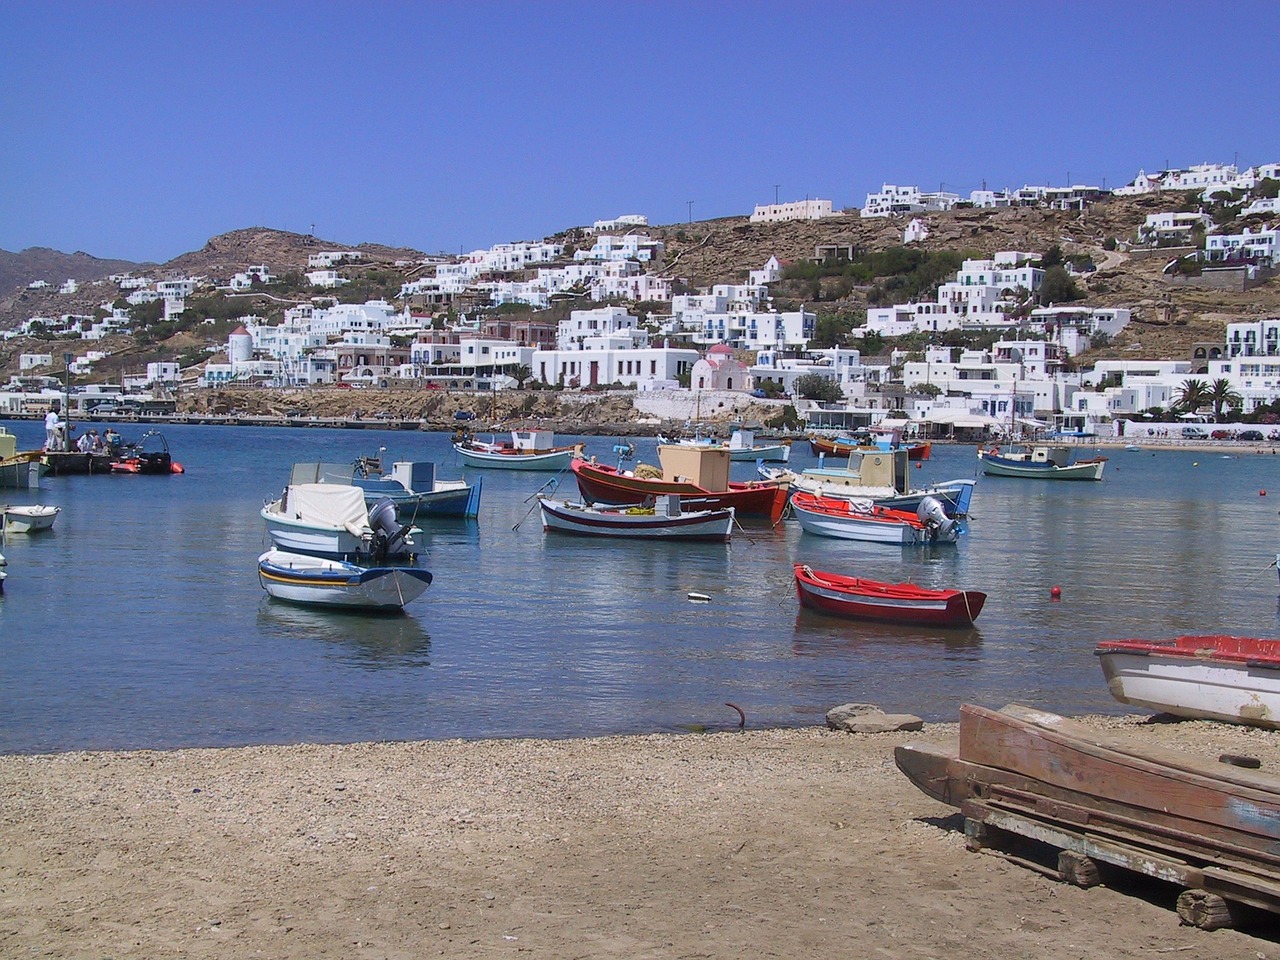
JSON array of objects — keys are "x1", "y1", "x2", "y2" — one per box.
[{"x1": 759, "y1": 449, "x2": 975, "y2": 517}]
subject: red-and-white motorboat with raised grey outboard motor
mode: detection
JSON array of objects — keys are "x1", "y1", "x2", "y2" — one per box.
[{"x1": 791, "y1": 490, "x2": 960, "y2": 544}]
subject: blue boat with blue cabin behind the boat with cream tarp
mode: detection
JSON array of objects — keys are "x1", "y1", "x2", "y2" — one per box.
[{"x1": 289, "y1": 457, "x2": 483, "y2": 524}]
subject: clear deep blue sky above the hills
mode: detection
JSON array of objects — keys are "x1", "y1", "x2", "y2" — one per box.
[{"x1": 0, "y1": 0, "x2": 1280, "y2": 261}]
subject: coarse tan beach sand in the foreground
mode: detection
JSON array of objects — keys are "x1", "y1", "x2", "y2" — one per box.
[{"x1": 0, "y1": 717, "x2": 1280, "y2": 960}]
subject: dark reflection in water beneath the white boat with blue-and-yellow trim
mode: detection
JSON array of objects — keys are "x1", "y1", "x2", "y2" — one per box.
[{"x1": 257, "y1": 596, "x2": 431, "y2": 669}]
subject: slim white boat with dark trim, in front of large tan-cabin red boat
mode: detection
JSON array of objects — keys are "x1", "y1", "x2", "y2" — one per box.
[{"x1": 539, "y1": 494, "x2": 733, "y2": 543}]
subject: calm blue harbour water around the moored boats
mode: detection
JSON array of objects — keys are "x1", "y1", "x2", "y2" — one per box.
[{"x1": 0, "y1": 421, "x2": 1280, "y2": 753}]
